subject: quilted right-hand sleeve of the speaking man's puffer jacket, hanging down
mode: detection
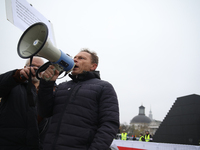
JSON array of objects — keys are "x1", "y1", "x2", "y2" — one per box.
[{"x1": 88, "y1": 83, "x2": 119, "y2": 150}]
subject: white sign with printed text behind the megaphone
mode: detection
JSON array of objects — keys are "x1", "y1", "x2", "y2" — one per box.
[{"x1": 5, "y1": 0, "x2": 56, "y2": 46}]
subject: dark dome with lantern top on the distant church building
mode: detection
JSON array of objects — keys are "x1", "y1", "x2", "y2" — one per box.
[{"x1": 130, "y1": 106, "x2": 151, "y2": 124}]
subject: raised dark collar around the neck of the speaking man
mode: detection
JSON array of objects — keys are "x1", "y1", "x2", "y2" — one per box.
[{"x1": 69, "y1": 71, "x2": 101, "y2": 82}]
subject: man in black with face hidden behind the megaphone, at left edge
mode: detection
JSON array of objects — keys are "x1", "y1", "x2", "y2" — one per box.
[{"x1": 0, "y1": 57, "x2": 44, "y2": 150}]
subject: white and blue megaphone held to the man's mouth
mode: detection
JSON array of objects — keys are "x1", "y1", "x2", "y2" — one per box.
[{"x1": 17, "y1": 22, "x2": 75, "y2": 80}]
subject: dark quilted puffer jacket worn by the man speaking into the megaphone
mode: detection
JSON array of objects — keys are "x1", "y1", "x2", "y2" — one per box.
[{"x1": 38, "y1": 72, "x2": 119, "y2": 150}]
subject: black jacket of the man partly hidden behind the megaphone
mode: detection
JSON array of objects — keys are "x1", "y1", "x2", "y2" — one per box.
[{"x1": 0, "y1": 70, "x2": 39, "y2": 150}]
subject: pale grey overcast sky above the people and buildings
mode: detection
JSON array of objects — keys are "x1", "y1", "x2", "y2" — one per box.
[{"x1": 0, "y1": 0, "x2": 200, "y2": 124}]
